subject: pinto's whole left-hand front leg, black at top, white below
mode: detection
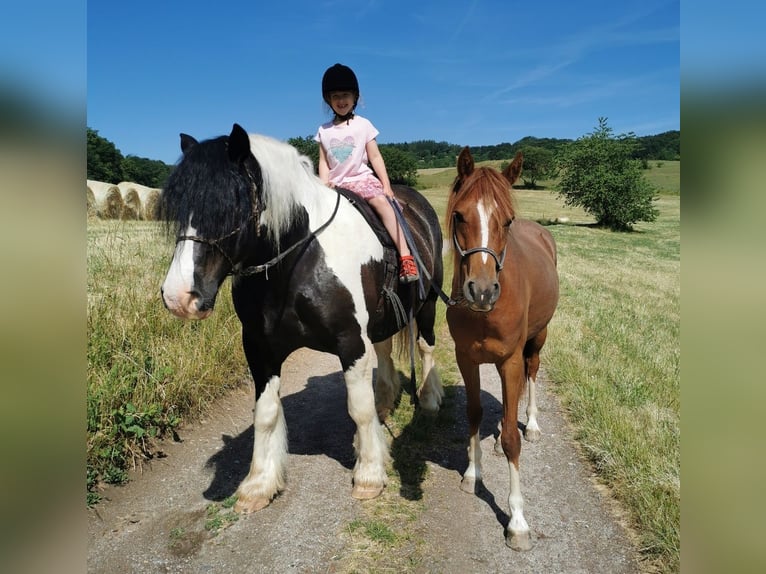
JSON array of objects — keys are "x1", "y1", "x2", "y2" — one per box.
[{"x1": 234, "y1": 335, "x2": 287, "y2": 513}]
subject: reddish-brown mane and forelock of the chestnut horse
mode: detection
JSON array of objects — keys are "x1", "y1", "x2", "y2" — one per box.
[{"x1": 445, "y1": 167, "x2": 516, "y2": 245}]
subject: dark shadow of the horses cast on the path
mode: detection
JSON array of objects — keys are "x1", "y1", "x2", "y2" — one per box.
[{"x1": 203, "y1": 371, "x2": 509, "y2": 528}]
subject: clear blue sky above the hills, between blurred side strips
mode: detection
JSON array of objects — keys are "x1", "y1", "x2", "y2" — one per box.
[{"x1": 87, "y1": 0, "x2": 680, "y2": 164}]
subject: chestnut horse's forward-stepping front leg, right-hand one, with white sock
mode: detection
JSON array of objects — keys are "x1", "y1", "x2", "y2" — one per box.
[{"x1": 497, "y1": 351, "x2": 532, "y2": 550}]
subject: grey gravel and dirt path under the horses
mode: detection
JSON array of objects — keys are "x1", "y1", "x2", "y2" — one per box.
[{"x1": 88, "y1": 350, "x2": 639, "y2": 574}]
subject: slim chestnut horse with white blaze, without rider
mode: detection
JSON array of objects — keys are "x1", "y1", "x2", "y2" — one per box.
[{"x1": 446, "y1": 147, "x2": 559, "y2": 550}]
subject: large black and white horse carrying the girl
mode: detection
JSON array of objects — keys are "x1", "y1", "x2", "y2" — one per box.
[{"x1": 160, "y1": 124, "x2": 443, "y2": 512}]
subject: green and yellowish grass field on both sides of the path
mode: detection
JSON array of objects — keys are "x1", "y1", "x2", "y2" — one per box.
[{"x1": 87, "y1": 162, "x2": 681, "y2": 572}]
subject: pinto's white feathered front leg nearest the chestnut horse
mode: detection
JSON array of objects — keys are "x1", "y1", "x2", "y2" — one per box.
[{"x1": 341, "y1": 344, "x2": 389, "y2": 500}]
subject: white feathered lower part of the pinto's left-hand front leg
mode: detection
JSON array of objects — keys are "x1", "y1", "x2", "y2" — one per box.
[{"x1": 237, "y1": 376, "x2": 287, "y2": 500}]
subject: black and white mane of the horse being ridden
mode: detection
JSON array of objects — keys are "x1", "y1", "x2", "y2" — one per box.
[{"x1": 159, "y1": 134, "x2": 325, "y2": 244}]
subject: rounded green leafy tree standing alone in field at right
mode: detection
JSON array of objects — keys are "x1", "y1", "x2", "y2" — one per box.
[{"x1": 558, "y1": 117, "x2": 659, "y2": 231}]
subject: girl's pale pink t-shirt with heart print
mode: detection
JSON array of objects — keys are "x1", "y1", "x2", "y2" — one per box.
[{"x1": 314, "y1": 115, "x2": 379, "y2": 185}]
